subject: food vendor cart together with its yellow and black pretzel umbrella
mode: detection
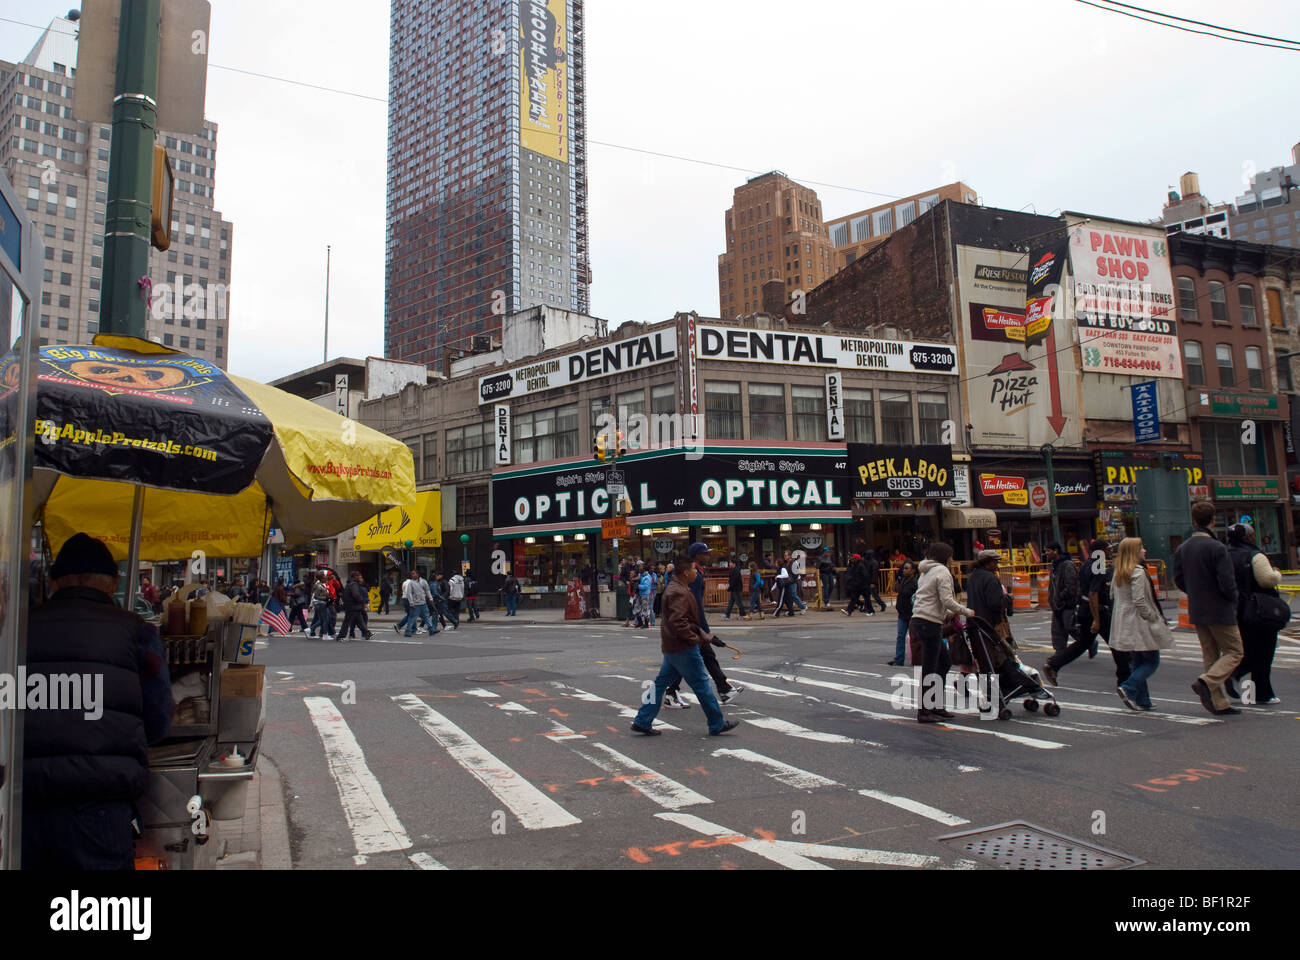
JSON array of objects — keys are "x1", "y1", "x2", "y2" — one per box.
[{"x1": 20, "y1": 336, "x2": 415, "y2": 869}]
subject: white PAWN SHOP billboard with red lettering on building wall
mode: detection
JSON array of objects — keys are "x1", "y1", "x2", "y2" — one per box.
[{"x1": 1070, "y1": 220, "x2": 1183, "y2": 380}]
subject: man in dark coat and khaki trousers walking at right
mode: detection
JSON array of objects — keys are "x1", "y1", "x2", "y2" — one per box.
[{"x1": 1174, "y1": 500, "x2": 1242, "y2": 715}]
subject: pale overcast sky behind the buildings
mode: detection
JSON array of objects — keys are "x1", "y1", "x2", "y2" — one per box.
[{"x1": 0, "y1": 0, "x2": 1300, "y2": 380}]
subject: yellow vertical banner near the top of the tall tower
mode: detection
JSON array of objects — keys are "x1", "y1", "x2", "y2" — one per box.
[{"x1": 519, "y1": 0, "x2": 572, "y2": 164}]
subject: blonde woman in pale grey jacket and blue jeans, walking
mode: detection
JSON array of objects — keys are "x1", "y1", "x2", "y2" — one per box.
[{"x1": 1110, "y1": 537, "x2": 1174, "y2": 710}]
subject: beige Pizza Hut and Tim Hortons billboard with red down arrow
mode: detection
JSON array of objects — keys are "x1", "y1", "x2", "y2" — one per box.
[{"x1": 957, "y1": 245, "x2": 1083, "y2": 450}]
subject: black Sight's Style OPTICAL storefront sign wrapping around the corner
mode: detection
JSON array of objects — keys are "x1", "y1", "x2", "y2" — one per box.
[{"x1": 491, "y1": 447, "x2": 853, "y2": 537}]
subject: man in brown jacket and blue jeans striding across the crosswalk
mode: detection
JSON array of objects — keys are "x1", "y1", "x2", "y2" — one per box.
[{"x1": 632, "y1": 557, "x2": 740, "y2": 736}]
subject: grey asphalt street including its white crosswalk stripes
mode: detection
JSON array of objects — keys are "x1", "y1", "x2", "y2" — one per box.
[{"x1": 257, "y1": 610, "x2": 1300, "y2": 870}]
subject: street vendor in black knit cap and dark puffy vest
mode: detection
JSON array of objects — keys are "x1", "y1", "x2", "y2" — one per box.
[{"x1": 22, "y1": 533, "x2": 174, "y2": 870}]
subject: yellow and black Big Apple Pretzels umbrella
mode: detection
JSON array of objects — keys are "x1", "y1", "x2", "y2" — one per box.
[{"x1": 0, "y1": 336, "x2": 415, "y2": 587}]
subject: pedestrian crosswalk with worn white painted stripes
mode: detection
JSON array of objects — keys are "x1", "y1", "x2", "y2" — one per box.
[{"x1": 277, "y1": 662, "x2": 1282, "y2": 870}]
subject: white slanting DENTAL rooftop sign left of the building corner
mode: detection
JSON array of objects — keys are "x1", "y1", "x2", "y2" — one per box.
[{"x1": 478, "y1": 329, "x2": 677, "y2": 403}]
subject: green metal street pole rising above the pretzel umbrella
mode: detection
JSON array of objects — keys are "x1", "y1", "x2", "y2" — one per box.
[{"x1": 99, "y1": 0, "x2": 163, "y2": 338}]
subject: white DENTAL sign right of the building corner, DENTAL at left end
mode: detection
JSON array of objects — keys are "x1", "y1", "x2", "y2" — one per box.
[{"x1": 698, "y1": 324, "x2": 957, "y2": 376}]
